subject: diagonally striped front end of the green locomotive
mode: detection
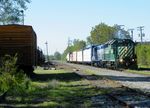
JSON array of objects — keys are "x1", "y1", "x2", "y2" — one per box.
[{"x1": 116, "y1": 39, "x2": 137, "y2": 68}]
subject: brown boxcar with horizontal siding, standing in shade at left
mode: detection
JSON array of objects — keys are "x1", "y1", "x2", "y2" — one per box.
[{"x1": 0, "y1": 25, "x2": 37, "y2": 74}]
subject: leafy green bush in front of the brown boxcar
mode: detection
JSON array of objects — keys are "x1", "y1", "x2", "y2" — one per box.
[{"x1": 0, "y1": 55, "x2": 30, "y2": 96}]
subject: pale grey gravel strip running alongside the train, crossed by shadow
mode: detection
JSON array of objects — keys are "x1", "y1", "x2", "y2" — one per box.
[{"x1": 62, "y1": 63, "x2": 150, "y2": 93}]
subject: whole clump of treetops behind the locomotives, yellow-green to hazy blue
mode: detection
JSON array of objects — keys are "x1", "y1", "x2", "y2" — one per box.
[{"x1": 87, "y1": 23, "x2": 130, "y2": 44}]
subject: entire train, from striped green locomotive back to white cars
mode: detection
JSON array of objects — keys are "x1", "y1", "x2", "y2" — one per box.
[{"x1": 66, "y1": 38, "x2": 137, "y2": 69}]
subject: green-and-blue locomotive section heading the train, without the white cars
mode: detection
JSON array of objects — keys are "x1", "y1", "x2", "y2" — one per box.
[{"x1": 96, "y1": 39, "x2": 137, "y2": 68}]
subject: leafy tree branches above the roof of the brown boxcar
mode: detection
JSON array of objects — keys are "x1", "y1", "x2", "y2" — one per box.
[{"x1": 0, "y1": 0, "x2": 30, "y2": 25}]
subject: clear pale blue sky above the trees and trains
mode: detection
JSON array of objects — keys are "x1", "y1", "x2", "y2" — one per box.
[{"x1": 24, "y1": 0, "x2": 150, "y2": 55}]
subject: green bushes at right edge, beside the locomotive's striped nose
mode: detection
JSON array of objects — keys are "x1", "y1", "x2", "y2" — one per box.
[{"x1": 136, "y1": 44, "x2": 150, "y2": 67}]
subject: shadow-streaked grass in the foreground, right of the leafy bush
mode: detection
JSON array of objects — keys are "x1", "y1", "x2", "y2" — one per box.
[{"x1": 0, "y1": 69, "x2": 107, "y2": 108}]
